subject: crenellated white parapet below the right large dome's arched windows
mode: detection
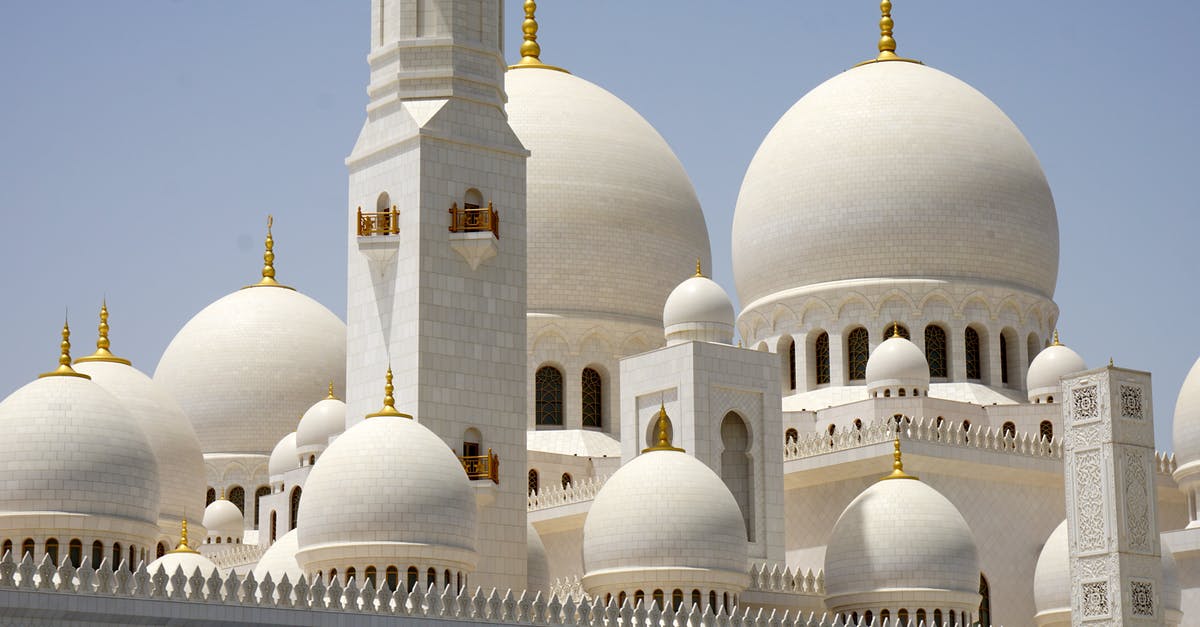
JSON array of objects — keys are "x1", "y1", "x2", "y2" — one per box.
[{"x1": 784, "y1": 418, "x2": 1177, "y2": 476}]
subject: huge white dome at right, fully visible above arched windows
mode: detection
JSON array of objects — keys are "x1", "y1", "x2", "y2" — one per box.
[{"x1": 732, "y1": 62, "x2": 1058, "y2": 309}]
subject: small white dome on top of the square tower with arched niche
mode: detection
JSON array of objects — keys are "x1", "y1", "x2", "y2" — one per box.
[{"x1": 662, "y1": 274, "x2": 733, "y2": 344}]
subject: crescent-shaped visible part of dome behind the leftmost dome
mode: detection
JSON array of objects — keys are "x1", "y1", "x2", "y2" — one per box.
[{"x1": 74, "y1": 358, "x2": 206, "y2": 533}]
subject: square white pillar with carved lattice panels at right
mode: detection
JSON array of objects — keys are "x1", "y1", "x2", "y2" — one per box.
[{"x1": 1062, "y1": 365, "x2": 1165, "y2": 626}]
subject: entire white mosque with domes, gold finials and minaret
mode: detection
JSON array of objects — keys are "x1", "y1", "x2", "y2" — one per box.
[{"x1": 0, "y1": 0, "x2": 1200, "y2": 627}]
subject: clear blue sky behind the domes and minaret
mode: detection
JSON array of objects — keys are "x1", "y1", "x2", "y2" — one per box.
[{"x1": 0, "y1": 0, "x2": 1200, "y2": 449}]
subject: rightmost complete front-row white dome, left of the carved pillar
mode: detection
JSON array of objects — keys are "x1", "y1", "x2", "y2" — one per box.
[{"x1": 824, "y1": 479, "x2": 980, "y2": 613}]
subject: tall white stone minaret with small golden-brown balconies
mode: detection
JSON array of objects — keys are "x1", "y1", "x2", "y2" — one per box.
[{"x1": 346, "y1": 0, "x2": 528, "y2": 590}]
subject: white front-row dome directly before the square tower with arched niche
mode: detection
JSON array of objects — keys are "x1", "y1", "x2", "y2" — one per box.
[{"x1": 583, "y1": 450, "x2": 749, "y2": 596}]
